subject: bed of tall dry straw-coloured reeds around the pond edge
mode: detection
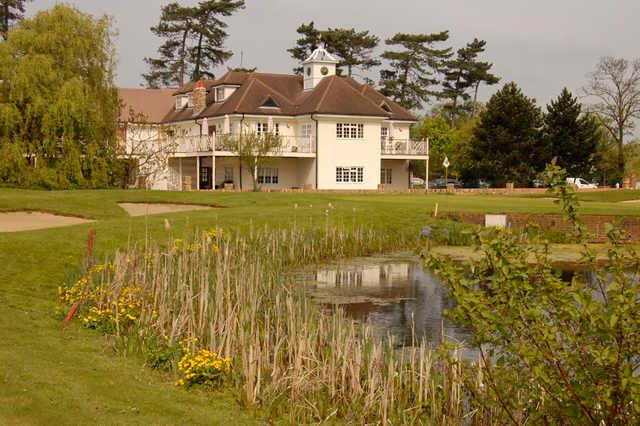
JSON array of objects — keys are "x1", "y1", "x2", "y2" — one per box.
[{"x1": 75, "y1": 226, "x2": 496, "y2": 424}]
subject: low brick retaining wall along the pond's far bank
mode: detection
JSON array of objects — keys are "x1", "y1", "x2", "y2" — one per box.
[{"x1": 442, "y1": 213, "x2": 640, "y2": 243}]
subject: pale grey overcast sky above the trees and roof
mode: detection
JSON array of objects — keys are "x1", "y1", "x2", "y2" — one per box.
[{"x1": 28, "y1": 0, "x2": 640, "y2": 104}]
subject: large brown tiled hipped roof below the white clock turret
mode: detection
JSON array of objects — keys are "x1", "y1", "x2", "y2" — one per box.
[{"x1": 132, "y1": 71, "x2": 416, "y2": 122}]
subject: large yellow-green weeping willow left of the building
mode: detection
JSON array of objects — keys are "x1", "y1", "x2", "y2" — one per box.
[{"x1": 0, "y1": 5, "x2": 119, "y2": 187}]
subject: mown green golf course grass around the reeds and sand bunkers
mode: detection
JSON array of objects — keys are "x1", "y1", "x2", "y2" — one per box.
[{"x1": 0, "y1": 189, "x2": 640, "y2": 424}]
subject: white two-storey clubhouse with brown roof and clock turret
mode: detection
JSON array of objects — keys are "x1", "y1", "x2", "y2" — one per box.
[{"x1": 120, "y1": 45, "x2": 428, "y2": 190}]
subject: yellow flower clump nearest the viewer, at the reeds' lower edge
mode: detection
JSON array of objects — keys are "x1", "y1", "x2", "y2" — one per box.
[{"x1": 176, "y1": 346, "x2": 231, "y2": 388}]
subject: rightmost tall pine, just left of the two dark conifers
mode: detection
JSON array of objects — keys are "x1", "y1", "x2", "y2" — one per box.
[{"x1": 442, "y1": 38, "x2": 500, "y2": 126}]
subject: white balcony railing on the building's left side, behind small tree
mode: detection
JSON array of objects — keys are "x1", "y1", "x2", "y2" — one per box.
[{"x1": 170, "y1": 135, "x2": 316, "y2": 155}]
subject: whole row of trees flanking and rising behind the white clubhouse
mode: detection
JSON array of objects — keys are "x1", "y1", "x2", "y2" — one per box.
[{"x1": 0, "y1": 0, "x2": 640, "y2": 187}]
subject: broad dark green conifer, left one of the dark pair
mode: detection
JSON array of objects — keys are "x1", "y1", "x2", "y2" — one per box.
[{"x1": 469, "y1": 83, "x2": 547, "y2": 185}]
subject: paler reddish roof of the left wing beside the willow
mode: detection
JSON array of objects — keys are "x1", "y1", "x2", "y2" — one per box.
[{"x1": 118, "y1": 89, "x2": 175, "y2": 123}]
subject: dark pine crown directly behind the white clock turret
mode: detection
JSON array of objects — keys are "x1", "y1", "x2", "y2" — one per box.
[{"x1": 287, "y1": 21, "x2": 380, "y2": 77}]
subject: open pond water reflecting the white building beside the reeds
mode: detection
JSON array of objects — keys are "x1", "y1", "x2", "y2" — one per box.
[{"x1": 297, "y1": 255, "x2": 471, "y2": 346}]
